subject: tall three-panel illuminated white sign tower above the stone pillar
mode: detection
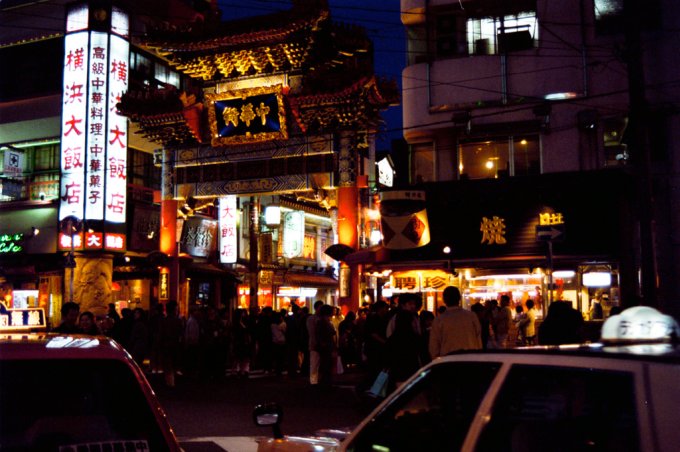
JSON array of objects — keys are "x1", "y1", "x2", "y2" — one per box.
[{"x1": 59, "y1": 5, "x2": 130, "y2": 251}]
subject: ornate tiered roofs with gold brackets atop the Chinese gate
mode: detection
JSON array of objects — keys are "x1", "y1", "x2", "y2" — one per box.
[{"x1": 119, "y1": 6, "x2": 399, "y2": 147}]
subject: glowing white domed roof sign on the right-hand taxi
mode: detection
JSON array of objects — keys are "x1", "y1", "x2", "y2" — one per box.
[{"x1": 601, "y1": 306, "x2": 680, "y2": 342}]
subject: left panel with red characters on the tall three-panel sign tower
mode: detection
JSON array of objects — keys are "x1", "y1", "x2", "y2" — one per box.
[{"x1": 59, "y1": 31, "x2": 89, "y2": 220}]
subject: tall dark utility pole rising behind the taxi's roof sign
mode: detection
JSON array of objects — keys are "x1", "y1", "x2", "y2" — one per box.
[{"x1": 623, "y1": 0, "x2": 657, "y2": 307}]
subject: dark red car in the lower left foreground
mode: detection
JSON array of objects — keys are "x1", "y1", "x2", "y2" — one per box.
[{"x1": 0, "y1": 310, "x2": 181, "y2": 452}]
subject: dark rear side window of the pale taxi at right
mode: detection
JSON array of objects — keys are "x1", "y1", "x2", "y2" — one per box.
[{"x1": 476, "y1": 365, "x2": 640, "y2": 452}]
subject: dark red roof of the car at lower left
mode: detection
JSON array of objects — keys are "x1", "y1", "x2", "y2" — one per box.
[{"x1": 0, "y1": 333, "x2": 131, "y2": 362}]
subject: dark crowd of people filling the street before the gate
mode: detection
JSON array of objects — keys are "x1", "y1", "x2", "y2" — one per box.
[{"x1": 47, "y1": 286, "x2": 582, "y2": 389}]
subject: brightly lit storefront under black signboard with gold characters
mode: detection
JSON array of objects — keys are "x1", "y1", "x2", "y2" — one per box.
[{"x1": 364, "y1": 172, "x2": 634, "y2": 318}]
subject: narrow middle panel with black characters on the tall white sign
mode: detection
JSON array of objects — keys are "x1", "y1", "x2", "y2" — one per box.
[{"x1": 85, "y1": 32, "x2": 109, "y2": 220}]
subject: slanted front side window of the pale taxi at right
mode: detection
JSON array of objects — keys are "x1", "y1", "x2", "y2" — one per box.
[{"x1": 347, "y1": 362, "x2": 500, "y2": 452}]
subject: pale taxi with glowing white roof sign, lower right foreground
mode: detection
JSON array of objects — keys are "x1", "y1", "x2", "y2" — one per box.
[{"x1": 254, "y1": 306, "x2": 680, "y2": 452}]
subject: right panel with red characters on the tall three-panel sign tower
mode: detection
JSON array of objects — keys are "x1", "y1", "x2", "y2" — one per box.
[{"x1": 105, "y1": 35, "x2": 130, "y2": 223}]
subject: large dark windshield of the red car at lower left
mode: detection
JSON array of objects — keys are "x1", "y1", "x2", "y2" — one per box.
[{"x1": 0, "y1": 360, "x2": 166, "y2": 452}]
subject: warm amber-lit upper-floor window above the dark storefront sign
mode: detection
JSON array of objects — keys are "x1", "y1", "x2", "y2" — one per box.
[{"x1": 458, "y1": 135, "x2": 541, "y2": 179}]
